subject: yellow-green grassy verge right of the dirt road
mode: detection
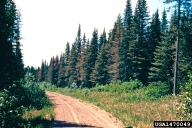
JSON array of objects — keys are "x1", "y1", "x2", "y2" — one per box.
[{"x1": 41, "y1": 81, "x2": 179, "y2": 128}]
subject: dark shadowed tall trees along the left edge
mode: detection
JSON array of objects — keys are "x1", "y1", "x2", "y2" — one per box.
[{"x1": 0, "y1": 0, "x2": 24, "y2": 90}]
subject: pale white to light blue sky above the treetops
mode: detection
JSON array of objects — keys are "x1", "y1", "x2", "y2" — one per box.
[{"x1": 14, "y1": 0, "x2": 164, "y2": 67}]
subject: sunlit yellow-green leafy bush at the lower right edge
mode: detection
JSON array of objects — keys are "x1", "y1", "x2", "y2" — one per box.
[{"x1": 176, "y1": 73, "x2": 192, "y2": 120}]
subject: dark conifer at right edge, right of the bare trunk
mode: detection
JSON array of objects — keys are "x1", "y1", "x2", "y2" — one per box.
[{"x1": 178, "y1": 12, "x2": 192, "y2": 84}]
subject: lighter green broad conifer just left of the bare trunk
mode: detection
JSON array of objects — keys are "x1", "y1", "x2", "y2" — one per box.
[{"x1": 149, "y1": 9, "x2": 177, "y2": 92}]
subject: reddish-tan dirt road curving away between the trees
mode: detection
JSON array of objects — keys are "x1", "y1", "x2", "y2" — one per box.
[{"x1": 46, "y1": 91, "x2": 124, "y2": 128}]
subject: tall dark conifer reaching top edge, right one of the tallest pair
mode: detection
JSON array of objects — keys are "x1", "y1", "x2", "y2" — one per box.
[{"x1": 128, "y1": 0, "x2": 149, "y2": 84}]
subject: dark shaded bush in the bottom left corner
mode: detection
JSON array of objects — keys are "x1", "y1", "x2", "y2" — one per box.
[{"x1": 0, "y1": 82, "x2": 27, "y2": 127}]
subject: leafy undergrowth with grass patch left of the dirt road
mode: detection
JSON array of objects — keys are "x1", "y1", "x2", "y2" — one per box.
[{"x1": 0, "y1": 73, "x2": 54, "y2": 128}]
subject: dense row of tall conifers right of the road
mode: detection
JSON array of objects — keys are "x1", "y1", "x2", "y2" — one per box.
[{"x1": 38, "y1": 0, "x2": 192, "y2": 92}]
